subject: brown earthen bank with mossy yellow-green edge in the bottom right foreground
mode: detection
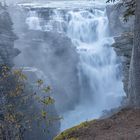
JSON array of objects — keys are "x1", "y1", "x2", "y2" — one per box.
[{"x1": 54, "y1": 108, "x2": 140, "y2": 140}]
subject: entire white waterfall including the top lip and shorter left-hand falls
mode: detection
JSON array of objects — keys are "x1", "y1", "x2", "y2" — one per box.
[{"x1": 17, "y1": 1, "x2": 124, "y2": 130}]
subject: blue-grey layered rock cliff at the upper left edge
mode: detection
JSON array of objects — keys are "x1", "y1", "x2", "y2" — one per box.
[{"x1": 0, "y1": 4, "x2": 20, "y2": 67}]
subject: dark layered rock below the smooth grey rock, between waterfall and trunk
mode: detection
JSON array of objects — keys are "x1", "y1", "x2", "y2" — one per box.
[{"x1": 112, "y1": 32, "x2": 133, "y2": 96}]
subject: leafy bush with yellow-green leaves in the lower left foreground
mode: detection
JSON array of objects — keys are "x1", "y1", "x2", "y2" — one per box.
[{"x1": 0, "y1": 65, "x2": 59, "y2": 140}]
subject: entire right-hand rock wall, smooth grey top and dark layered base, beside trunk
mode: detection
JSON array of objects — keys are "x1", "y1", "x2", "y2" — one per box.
[{"x1": 107, "y1": 4, "x2": 134, "y2": 96}]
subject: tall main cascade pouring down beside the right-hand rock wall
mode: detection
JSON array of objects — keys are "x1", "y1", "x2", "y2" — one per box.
[{"x1": 62, "y1": 9, "x2": 123, "y2": 128}]
